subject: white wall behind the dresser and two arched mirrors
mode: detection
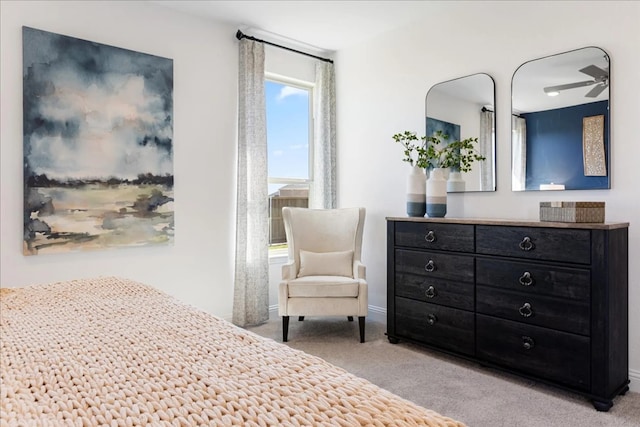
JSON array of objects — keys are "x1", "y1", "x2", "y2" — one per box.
[{"x1": 336, "y1": 1, "x2": 640, "y2": 391}]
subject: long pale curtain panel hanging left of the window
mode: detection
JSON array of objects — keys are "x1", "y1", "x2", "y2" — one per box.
[{"x1": 232, "y1": 39, "x2": 269, "y2": 326}]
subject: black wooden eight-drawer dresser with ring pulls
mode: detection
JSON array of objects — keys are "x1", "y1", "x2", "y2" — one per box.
[{"x1": 387, "y1": 218, "x2": 629, "y2": 411}]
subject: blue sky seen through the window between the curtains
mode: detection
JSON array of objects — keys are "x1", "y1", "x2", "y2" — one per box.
[{"x1": 265, "y1": 80, "x2": 309, "y2": 193}]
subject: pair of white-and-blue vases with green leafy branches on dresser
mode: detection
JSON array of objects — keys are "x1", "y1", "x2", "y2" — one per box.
[{"x1": 393, "y1": 131, "x2": 485, "y2": 217}]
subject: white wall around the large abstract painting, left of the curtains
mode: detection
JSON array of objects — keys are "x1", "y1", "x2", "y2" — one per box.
[{"x1": 0, "y1": 1, "x2": 238, "y2": 318}]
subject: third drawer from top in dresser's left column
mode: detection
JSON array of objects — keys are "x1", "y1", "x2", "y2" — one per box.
[{"x1": 396, "y1": 272, "x2": 474, "y2": 310}]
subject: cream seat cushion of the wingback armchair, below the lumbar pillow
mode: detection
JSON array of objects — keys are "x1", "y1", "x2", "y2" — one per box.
[{"x1": 288, "y1": 276, "x2": 360, "y2": 298}]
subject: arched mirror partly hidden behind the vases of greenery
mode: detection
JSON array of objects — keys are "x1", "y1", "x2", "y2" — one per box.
[{"x1": 425, "y1": 73, "x2": 496, "y2": 193}]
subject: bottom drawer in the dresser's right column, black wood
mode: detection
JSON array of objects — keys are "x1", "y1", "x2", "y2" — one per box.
[{"x1": 476, "y1": 314, "x2": 591, "y2": 390}]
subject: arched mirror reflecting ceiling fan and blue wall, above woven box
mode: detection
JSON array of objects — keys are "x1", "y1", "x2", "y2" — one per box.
[{"x1": 511, "y1": 47, "x2": 611, "y2": 191}]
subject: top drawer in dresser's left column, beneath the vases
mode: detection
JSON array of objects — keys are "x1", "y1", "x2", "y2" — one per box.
[{"x1": 395, "y1": 222, "x2": 474, "y2": 252}]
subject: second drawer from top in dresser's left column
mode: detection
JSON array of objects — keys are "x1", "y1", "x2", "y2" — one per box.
[{"x1": 395, "y1": 249, "x2": 475, "y2": 283}]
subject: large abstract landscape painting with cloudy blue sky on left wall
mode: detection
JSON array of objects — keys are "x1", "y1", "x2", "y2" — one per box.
[{"x1": 22, "y1": 27, "x2": 174, "y2": 255}]
